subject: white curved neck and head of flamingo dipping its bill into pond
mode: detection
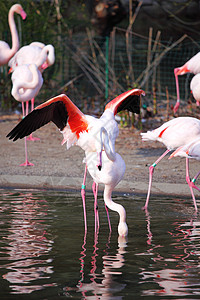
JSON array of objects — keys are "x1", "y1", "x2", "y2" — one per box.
[{"x1": 104, "y1": 185, "x2": 128, "y2": 236}]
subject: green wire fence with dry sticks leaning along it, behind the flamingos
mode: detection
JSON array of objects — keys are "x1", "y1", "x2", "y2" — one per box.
[{"x1": 0, "y1": 28, "x2": 200, "y2": 116}]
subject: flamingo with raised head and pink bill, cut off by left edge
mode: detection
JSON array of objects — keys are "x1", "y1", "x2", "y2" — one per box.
[{"x1": 0, "y1": 4, "x2": 26, "y2": 66}]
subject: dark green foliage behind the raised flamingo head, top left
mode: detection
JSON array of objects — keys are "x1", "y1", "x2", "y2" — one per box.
[{"x1": 0, "y1": 0, "x2": 90, "y2": 45}]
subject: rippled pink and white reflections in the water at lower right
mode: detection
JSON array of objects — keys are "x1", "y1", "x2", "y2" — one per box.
[{"x1": 139, "y1": 212, "x2": 200, "y2": 296}]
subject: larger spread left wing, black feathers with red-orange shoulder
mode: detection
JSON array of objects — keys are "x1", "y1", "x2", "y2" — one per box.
[{"x1": 6, "y1": 94, "x2": 88, "y2": 141}]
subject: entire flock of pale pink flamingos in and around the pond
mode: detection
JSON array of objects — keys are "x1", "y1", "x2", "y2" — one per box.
[{"x1": 3, "y1": 4, "x2": 200, "y2": 237}]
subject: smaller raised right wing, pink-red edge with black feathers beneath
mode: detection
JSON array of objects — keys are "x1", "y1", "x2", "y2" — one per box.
[{"x1": 105, "y1": 89, "x2": 145, "y2": 115}]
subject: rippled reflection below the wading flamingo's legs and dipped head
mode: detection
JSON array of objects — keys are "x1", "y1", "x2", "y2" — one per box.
[{"x1": 63, "y1": 232, "x2": 127, "y2": 299}]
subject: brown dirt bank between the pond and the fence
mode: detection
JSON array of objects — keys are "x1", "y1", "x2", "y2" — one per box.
[{"x1": 0, "y1": 114, "x2": 199, "y2": 196}]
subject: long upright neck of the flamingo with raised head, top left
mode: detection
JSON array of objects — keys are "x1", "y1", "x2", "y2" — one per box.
[{"x1": 8, "y1": 7, "x2": 19, "y2": 58}]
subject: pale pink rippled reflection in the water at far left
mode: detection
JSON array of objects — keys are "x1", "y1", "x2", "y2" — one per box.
[{"x1": 1, "y1": 193, "x2": 53, "y2": 294}]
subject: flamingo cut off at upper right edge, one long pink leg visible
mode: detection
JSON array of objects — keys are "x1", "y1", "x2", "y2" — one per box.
[{"x1": 174, "y1": 52, "x2": 200, "y2": 113}]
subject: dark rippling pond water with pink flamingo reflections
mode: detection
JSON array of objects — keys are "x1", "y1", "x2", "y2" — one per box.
[{"x1": 0, "y1": 190, "x2": 200, "y2": 300}]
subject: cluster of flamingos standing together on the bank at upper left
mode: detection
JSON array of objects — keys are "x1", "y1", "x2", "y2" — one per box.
[{"x1": 0, "y1": 4, "x2": 55, "y2": 166}]
